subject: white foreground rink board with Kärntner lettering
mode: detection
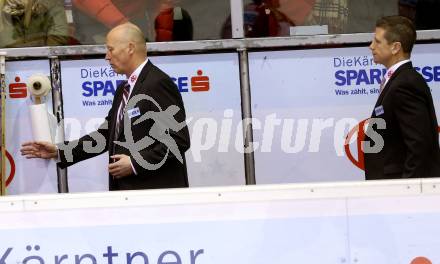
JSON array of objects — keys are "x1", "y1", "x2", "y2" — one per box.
[{"x1": 0, "y1": 182, "x2": 440, "y2": 264}]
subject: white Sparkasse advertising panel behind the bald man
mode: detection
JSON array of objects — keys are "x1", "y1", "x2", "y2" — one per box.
[{"x1": 61, "y1": 53, "x2": 244, "y2": 192}]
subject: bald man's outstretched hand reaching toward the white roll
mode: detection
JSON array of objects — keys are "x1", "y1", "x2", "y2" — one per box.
[{"x1": 20, "y1": 141, "x2": 58, "y2": 159}]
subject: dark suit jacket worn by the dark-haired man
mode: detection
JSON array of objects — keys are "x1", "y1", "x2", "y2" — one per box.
[{"x1": 364, "y1": 62, "x2": 440, "y2": 180}]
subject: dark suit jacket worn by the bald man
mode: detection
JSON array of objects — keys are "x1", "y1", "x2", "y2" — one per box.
[{"x1": 58, "y1": 61, "x2": 190, "y2": 190}]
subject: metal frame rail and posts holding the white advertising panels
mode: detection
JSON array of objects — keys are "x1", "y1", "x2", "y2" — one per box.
[{"x1": 0, "y1": 29, "x2": 440, "y2": 192}]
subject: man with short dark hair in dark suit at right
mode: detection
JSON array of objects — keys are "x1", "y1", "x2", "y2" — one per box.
[{"x1": 363, "y1": 16, "x2": 440, "y2": 180}]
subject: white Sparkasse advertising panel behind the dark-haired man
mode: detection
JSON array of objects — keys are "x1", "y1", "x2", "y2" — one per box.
[{"x1": 249, "y1": 44, "x2": 440, "y2": 183}]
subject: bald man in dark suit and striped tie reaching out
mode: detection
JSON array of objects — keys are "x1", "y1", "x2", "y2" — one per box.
[{"x1": 21, "y1": 23, "x2": 190, "y2": 190}]
